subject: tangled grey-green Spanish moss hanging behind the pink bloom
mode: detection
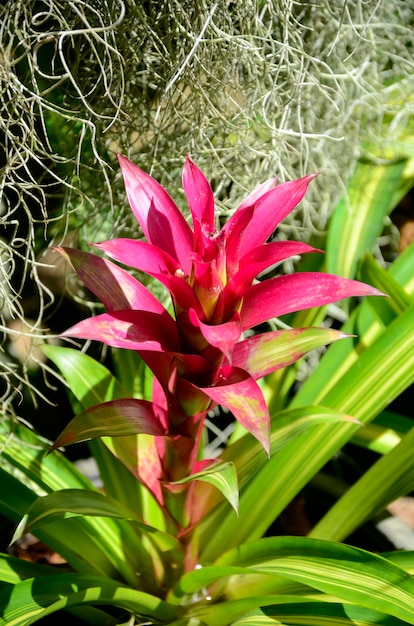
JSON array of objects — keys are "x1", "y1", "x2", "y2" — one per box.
[{"x1": 0, "y1": 0, "x2": 414, "y2": 401}]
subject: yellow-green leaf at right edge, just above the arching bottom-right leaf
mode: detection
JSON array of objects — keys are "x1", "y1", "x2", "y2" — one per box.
[{"x1": 310, "y1": 428, "x2": 414, "y2": 541}]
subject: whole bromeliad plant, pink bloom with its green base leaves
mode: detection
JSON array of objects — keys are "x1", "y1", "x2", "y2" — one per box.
[{"x1": 0, "y1": 156, "x2": 414, "y2": 626}]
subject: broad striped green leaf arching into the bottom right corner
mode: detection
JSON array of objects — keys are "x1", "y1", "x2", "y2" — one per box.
[{"x1": 215, "y1": 537, "x2": 414, "y2": 624}]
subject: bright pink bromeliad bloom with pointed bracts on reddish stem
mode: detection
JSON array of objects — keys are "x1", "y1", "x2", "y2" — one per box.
[{"x1": 54, "y1": 156, "x2": 379, "y2": 504}]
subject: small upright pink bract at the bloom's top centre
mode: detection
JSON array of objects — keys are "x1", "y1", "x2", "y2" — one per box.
[{"x1": 183, "y1": 157, "x2": 214, "y2": 234}]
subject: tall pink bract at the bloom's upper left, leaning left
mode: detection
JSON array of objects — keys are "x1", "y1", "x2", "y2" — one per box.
[{"x1": 118, "y1": 154, "x2": 193, "y2": 273}]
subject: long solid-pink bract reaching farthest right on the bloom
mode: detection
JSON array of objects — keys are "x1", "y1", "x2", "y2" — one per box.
[{"x1": 240, "y1": 272, "x2": 384, "y2": 330}]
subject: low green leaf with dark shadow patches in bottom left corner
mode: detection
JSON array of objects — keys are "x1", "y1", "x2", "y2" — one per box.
[{"x1": 0, "y1": 574, "x2": 182, "y2": 626}]
